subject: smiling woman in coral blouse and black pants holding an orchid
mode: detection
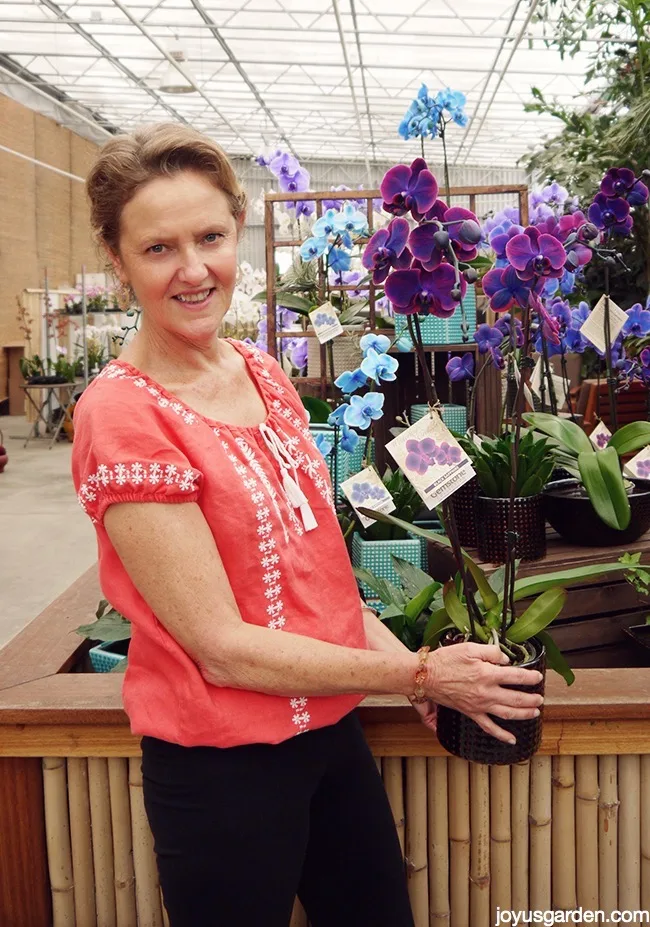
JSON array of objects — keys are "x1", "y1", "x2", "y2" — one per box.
[{"x1": 73, "y1": 125, "x2": 541, "y2": 927}]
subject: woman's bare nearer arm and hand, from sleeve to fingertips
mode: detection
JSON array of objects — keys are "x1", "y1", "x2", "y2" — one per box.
[{"x1": 104, "y1": 502, "x2": 540, "y2": 737}]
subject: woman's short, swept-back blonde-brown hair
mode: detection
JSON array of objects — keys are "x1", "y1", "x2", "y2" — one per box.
[{"x1": 86, "y1": 122, "x2": 246, "y2": 254}]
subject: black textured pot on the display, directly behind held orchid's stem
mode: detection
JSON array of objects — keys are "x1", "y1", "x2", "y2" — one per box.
[{"x1": 476, "y1": 493, "x2": 546, "y2": 563}]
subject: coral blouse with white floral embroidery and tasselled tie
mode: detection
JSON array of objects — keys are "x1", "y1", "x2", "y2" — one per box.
[{"x1": 72, "y1": 341, "x2": 366, "y2": 747}]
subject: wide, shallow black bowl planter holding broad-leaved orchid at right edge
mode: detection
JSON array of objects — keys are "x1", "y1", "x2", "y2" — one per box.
[{"x1": 543, "y1": 479, "x2": 650, "y2": 547}]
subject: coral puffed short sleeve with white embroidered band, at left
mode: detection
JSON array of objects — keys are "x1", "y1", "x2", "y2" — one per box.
[{"x1": 72, "y1": 380, "x2": 202, "y2": 524}]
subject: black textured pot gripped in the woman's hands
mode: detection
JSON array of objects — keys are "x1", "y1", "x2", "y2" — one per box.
[{"x1": 437, "y1": 638, "x2": 546, "y2": 766}]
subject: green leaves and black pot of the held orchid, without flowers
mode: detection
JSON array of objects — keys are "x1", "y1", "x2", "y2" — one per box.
[{"x1": 355, "y1": 509, "x2": 642, "y2": 764}]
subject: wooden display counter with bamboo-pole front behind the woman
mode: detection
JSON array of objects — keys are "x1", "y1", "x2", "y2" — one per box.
[{"x1": 0, "y1": 540, "x2": 650, "y2": 927}]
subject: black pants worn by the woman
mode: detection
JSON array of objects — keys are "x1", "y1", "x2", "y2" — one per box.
[{"x1": 142, "y1": 713, "x2": 413, "y2": 927}]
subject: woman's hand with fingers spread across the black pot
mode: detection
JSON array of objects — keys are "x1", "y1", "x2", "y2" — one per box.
[{"x1": 424, "y1": 644, "x2": 544, "y2": 744}]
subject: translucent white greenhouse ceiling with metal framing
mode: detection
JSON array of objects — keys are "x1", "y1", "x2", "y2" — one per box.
[{"x1": 0, "y1": 0, "x2": 624, "y2": 166}]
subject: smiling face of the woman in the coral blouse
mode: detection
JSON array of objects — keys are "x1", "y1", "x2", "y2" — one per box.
[{"x1": 113, "y1": 171, "x2": 239, "y2": 342}]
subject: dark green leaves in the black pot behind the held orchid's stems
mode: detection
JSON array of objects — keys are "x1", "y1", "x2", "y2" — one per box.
[{"x1": 460, "y1": 431, "x2": 552, "y2": 499}]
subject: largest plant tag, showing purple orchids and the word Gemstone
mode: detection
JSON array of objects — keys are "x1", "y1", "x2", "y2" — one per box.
[{"x1": 386, "y1": 412, "x2": 474, "y2": 509}]
